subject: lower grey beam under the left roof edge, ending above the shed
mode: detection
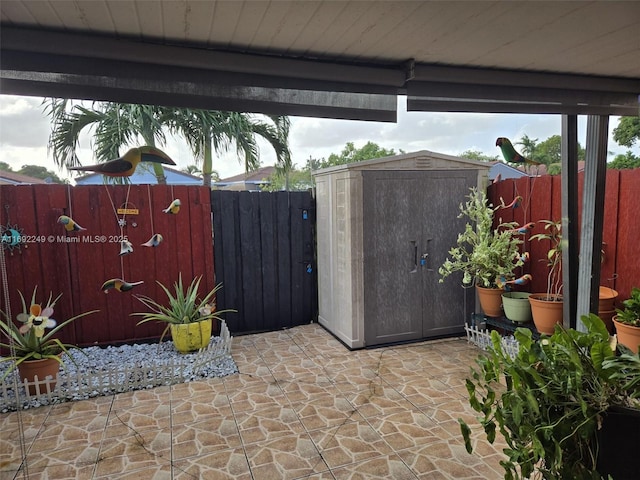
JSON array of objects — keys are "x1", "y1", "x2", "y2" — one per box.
[{"x1": 0, "y1": 69, "x2": 397, "y2": 122}]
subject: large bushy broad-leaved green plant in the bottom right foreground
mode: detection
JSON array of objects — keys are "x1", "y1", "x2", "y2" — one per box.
[{"x1": 459, "y1": 315, "x2": 640, "y2": 479}]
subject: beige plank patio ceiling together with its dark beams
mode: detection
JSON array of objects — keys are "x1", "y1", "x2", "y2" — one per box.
[{"x1": 0, "y1": 0, "x2": 640, "y2": 121}]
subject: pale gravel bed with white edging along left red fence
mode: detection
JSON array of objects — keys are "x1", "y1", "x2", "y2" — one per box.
[{"x1": 0, "y1": 337, "x2": 238, "y2": 413}]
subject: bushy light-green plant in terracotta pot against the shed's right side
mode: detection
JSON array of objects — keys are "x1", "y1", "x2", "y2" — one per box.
[{"x1": 438, "y1": 188, "x2": 524, "y2": 317}]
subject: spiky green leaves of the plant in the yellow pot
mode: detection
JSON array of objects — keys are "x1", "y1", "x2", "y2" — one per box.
[{"x1": 131, "y1": 274, "x2": 236, "y2": 341}]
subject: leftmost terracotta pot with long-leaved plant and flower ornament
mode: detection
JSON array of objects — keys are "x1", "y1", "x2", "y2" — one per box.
[{"x1": 0, "y1": 287, "x2": 98, "y2": 395}]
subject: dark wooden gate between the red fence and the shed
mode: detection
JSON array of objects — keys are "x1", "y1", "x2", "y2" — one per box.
[{"x1": 211, "y1": 190, "x2": 317, "y2": 333}]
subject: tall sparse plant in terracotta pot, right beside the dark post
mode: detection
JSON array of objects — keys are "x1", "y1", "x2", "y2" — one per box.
[{"x1": 529, "y1": 220, "x2": 563, "y2": 335}]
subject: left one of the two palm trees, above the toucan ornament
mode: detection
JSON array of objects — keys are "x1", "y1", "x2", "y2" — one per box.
[{"x1": 45, "y1": 98, "x2": 172, "y2": 184}]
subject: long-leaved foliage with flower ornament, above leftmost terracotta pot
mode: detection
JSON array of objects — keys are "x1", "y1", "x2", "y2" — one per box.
[{"x1": 0, "y1": 287, "x2": 98, "y2": 380}]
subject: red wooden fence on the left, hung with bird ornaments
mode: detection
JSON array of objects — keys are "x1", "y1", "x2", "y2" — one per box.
[{"x1": 0, "y1": 185, "x2": 214, "y2": 345}]
